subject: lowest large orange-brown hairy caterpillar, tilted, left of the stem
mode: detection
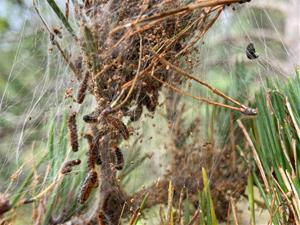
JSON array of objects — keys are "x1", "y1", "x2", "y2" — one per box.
[{"x1": 78, "y1": 170, "x2": 98, "y2": 204}]
